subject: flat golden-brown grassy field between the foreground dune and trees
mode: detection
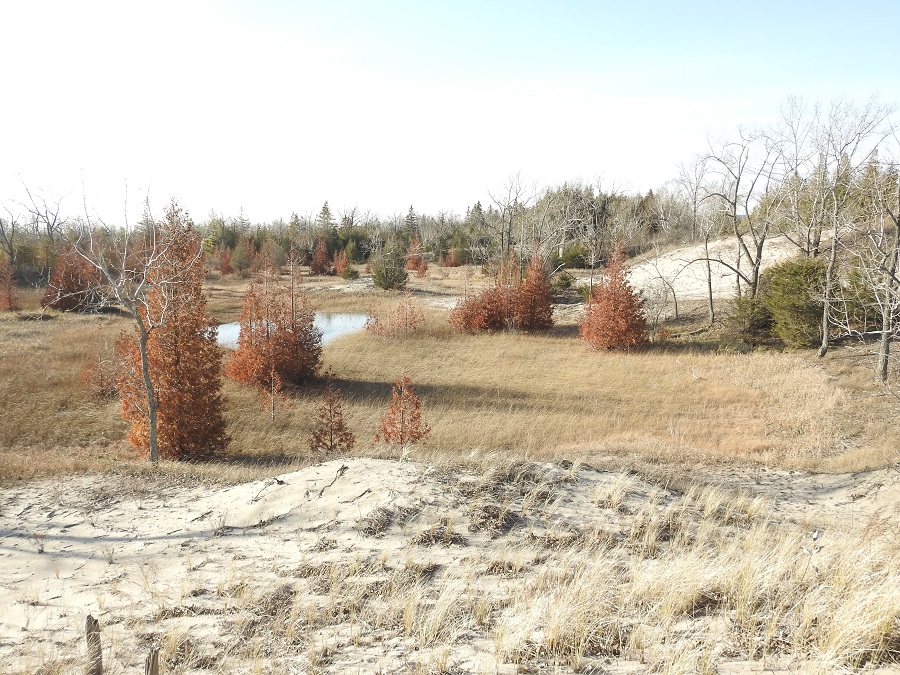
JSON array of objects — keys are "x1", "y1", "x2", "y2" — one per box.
[{"x1": 0, "y1": 268, "x2": 900, "y2": 478}]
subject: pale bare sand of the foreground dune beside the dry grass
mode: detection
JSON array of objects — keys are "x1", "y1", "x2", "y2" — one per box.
[{"x1": 0, "y1": 459, "x2": 900, "y2": 673}]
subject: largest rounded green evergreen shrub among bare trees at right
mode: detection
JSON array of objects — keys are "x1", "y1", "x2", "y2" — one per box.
[{"x1": 761, "y1": 258, "x2": 825, "y2": 348}]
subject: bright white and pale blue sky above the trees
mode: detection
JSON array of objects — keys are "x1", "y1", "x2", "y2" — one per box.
[{"x1": 0, "y1": 0, "x2": 900, "y2": 224}]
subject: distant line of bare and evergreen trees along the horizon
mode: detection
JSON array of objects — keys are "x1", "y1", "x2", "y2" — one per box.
[{"x1": 0, "y1": 99, "x2": 900, "y2": 381}]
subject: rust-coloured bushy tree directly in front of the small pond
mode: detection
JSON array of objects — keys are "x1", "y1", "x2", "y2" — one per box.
[{"x1": 225, "y1": 276, "x2": 322, "y2": 392}]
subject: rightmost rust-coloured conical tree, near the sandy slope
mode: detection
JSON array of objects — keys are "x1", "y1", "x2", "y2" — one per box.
[{"x1": 578, "y1": 244, "x2": 649, "y2": 349}]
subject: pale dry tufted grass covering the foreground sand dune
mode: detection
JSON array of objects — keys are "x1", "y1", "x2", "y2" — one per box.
[{"x1": 8, "y1": 456, "x2": 900, "y2": 673}]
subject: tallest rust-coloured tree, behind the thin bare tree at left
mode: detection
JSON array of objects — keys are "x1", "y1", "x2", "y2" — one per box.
[{"x1": 117, "y1": 202, "x2": 228, "y2": 460}]
